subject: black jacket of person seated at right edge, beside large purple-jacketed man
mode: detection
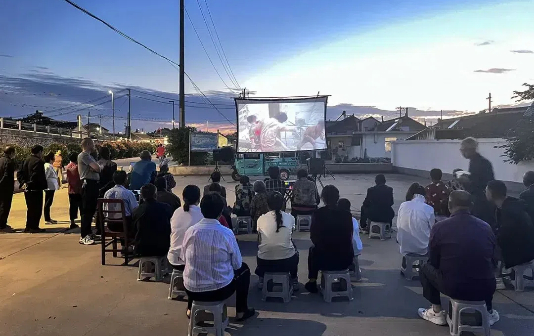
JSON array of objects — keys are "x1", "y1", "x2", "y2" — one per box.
[{"x1": 496, "y1": 197, "x2": 534, "y2": 268}]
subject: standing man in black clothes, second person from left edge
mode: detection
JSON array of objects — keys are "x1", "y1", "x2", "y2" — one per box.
[{"x1": 17, "y1": 145, "x2": 48, "y2": 233}]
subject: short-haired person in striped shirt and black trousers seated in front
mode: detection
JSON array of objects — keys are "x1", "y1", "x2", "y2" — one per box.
[{"x1": 180, "y1": 193, "x2": 255, "y2": 321}]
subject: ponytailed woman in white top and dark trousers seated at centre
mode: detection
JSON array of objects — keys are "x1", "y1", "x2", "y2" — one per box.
[{"x1": 256, "y1": 192, "x2": 299, "y2": 290}]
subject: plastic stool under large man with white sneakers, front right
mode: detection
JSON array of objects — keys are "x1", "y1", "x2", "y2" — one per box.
[{"x1": 447, "y1": 298, "x2": 490, "y2": 336}]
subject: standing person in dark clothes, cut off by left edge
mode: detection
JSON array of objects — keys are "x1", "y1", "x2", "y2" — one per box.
[{"x1": 0, "y1": 146, "x2": 15, "y2": 232}]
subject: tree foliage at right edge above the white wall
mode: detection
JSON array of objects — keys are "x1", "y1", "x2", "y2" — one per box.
[{"x1": 502, "y1": 83, "x2": 534, "y2": 164}]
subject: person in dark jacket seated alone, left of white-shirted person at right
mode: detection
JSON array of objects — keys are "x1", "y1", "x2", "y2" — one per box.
[{"x1": 360, "y1": 174, "x2": 395, "y2": 231}]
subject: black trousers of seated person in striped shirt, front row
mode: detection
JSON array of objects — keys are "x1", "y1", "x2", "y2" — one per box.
[{"x1": 185, "y1": 263, "x2": 250, "y2": 313}]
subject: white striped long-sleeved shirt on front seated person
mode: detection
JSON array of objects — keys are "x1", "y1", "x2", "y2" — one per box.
[{"x1": 180, "y1": 218, "x2": 243, "y2": 292}]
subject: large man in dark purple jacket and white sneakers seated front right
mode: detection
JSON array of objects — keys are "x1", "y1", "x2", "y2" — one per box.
[{"x1": 418, "y1": 190, "x2": 499, "y2": 325}]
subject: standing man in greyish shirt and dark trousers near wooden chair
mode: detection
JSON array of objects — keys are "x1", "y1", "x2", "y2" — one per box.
[{"x1": 78, "y1": 138, "x2": 100, "y2": 245}]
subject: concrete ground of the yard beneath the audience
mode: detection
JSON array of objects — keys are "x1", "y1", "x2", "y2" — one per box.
[{"x1": 0, "y1": 175, "x2": 534, "y2": 336}]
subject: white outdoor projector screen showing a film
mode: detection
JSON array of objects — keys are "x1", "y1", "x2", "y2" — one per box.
[{"x1": 235, "y1": 96, "x2": 328, "y2": 153}]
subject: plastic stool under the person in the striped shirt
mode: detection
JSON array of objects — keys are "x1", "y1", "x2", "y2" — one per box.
[{"x1": 188, "y1": 301, "x2": 228, "y2": 336}]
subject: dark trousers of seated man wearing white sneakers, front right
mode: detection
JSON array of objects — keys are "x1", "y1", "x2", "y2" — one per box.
[{"x1": 419, "y1": 263, "x2": 495, "y2": 311}]
